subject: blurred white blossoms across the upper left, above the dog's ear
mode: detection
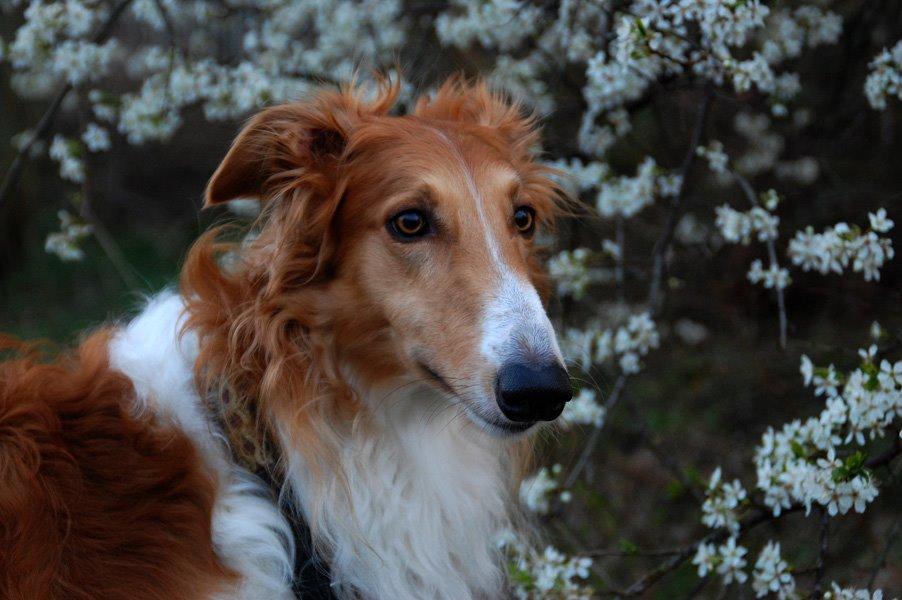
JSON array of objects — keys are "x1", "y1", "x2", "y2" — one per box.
[{"x1": 0, "y1": 0, "x2": 407, "y2": 173}]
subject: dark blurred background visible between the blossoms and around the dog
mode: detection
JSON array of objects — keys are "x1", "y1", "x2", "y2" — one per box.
[{"x1": 0, "y1": 0, "x2": 902, "y2": 598}]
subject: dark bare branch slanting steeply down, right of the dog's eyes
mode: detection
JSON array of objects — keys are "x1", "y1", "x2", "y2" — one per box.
[{"x1": 648, "y1": 87, "x2": 714, "y2": 315}]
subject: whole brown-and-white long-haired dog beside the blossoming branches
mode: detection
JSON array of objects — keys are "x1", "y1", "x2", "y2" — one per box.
[{"x1": 0, "y1": 81, "x2": 569, "y2": 599}]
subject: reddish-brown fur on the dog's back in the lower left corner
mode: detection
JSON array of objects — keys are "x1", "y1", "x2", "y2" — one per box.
[{"x1": 0, "y1": 332, "x2": 231, "y2": 600}]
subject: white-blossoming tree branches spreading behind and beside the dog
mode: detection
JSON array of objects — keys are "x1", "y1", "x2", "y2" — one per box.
[{"x1": 0, "y1": 0, "x2": 902, "y2": 600}]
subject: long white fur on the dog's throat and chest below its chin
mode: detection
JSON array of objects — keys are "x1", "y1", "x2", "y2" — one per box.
[{"x1": 278, "y1": 383, "x2": 514, "y2": 599}]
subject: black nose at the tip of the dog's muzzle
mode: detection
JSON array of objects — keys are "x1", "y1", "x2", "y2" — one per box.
[{"x1": 495, "y1": 363, "x2": 573, "y2": 423}]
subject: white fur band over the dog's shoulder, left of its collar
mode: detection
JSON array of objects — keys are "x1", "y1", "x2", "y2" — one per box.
[{"x1": 110, "y1": 292, "x2": 294, "y2": 600}]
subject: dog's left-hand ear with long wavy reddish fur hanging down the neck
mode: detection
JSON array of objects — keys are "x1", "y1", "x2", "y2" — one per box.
[{"x1": 181, "y1": 82, "x2": 398, "y2": 469}]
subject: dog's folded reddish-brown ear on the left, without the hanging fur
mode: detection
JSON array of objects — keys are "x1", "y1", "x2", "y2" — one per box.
[{"x1": 204, "y1": 91, "x2": 361, "y2": 207}]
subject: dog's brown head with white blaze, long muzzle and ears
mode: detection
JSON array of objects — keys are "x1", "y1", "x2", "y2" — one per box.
[{"x1": 206, "y1": 79, "x2": 571, "y2": 435}]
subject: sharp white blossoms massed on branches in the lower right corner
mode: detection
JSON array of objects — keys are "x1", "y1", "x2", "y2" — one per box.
[{"x1": 693, "y1": 323, "x2": 902, "y2": 598}]
